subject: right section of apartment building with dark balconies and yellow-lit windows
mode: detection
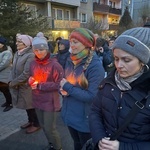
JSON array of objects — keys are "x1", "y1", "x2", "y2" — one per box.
[{"x1": 93, "y1": 0, "x2": 121, "y2": 36}]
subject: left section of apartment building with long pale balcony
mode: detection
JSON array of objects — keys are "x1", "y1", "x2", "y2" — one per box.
[{"x1": 23, "y1": 0, "x2": 80, "y2": 41}]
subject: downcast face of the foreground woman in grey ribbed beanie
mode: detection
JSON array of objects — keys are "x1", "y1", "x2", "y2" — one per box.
[{"x1": 113, "y1": 48, "x2": 143, "y2": 78}]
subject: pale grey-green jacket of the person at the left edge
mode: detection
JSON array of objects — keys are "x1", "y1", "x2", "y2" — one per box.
[{"x1": 0, "y1": 47, "x2": 13, "y2": 83}]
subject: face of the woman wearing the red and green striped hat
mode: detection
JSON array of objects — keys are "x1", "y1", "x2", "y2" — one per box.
[{"x1": 70, "y1": 38, "x2": 85, "y2": 54}]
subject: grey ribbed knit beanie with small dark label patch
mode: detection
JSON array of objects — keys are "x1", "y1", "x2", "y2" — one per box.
[{"x1": 113, "y1": 27, "x2": 150, "y2": 64}]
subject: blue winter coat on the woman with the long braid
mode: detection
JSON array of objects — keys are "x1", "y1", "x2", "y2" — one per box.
[{"x1": 62, "y1": 54, "x2": 104, "y2": 132}]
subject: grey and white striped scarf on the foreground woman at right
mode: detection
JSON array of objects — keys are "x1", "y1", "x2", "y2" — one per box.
[{"x1": 115, "y1": 69, "x2": 144, "y2": 91}]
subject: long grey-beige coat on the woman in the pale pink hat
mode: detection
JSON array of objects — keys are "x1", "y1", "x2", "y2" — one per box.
[{"x1": 10, "y1": 48, "x2": 34, "y2": 109}]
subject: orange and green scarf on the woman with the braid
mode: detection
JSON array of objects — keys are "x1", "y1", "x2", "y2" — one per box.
[{"x1": 70, "y1": 49, "x2": 89, "y2": 65}]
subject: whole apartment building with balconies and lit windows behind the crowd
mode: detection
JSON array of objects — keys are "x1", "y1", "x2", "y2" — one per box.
[{"x1": 23, "y1": 0, "x2": 121, "y2": 41}]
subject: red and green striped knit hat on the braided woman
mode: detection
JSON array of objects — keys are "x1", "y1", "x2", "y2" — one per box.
[{"x1": 70, "y1": 28, "x2": 96, "y2": 48}]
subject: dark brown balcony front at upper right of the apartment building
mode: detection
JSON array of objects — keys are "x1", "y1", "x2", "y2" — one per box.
[{"x1": 93, "y1": 2, "x2": 121, "y2": 15}]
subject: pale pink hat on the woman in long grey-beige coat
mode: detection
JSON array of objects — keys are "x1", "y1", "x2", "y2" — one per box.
[{"x1": 17, "y1": 34, "x2": 33, "y2": 47}]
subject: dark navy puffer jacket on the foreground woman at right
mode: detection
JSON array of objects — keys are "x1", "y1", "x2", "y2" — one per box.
[{"x1": 90, "y1": 68, "x2": 150, "y2": 150}]
